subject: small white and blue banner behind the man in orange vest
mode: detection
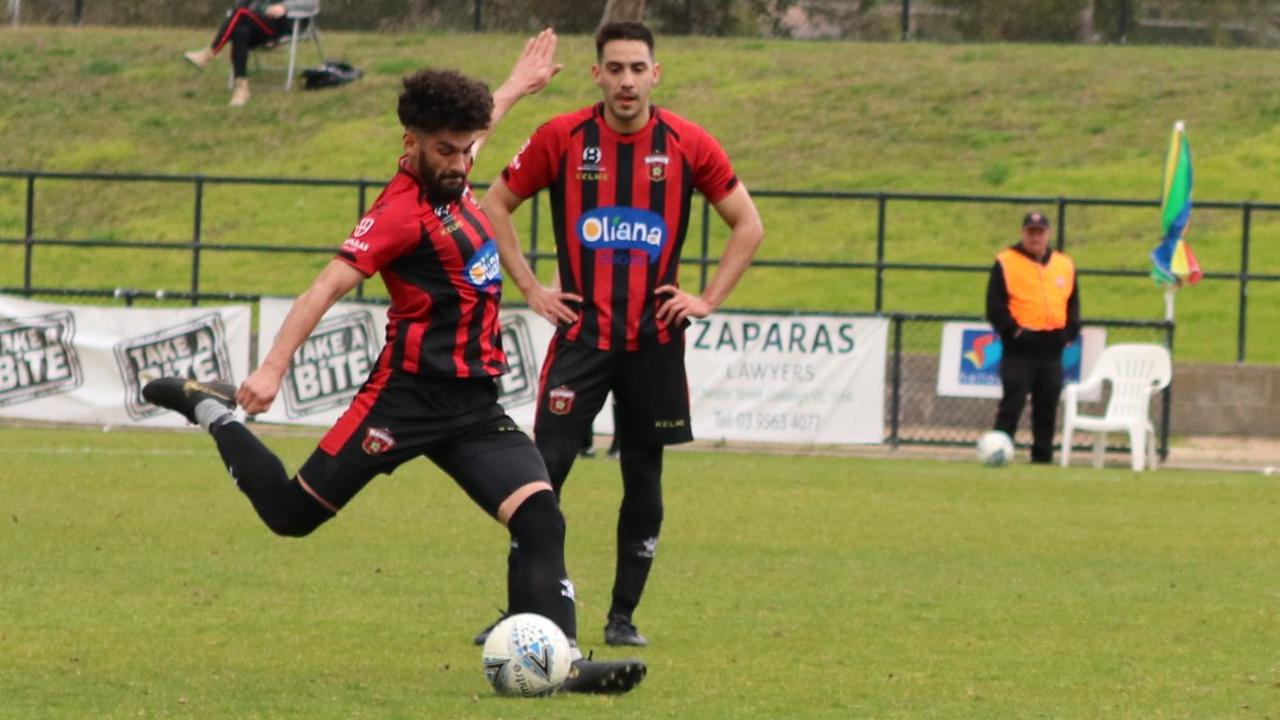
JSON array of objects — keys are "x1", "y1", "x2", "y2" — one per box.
[{"x1": 937, "y1": 323, "x2": 1107, "y2": 402}]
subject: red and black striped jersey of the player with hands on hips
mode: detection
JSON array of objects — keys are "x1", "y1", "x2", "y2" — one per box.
[{"x1": 502, "y1": 102, "x2": 737, "y2": 350}]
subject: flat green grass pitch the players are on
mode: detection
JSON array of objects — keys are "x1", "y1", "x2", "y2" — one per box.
[{"x1": 0, "y1": 428, "x2": 1280, "y2": 720}]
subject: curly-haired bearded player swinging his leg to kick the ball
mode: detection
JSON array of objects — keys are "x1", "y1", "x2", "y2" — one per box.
[{"x1": 142, "y1": 31, "x2": 645, "y2": 693}]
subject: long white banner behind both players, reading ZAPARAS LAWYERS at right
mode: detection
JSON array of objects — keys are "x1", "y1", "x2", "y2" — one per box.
[{"x1": 257, "y1": 299, "x2": 888, "y2": 443}]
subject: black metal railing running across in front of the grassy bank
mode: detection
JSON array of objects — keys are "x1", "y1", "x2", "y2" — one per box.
[{"x1": 0, "y1": 170, "x2": 1280, "y2": 363}]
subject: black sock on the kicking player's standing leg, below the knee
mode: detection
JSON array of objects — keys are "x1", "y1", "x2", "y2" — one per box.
[{"x1": 507, "y1": 491, "x2": 577, "y2": 641}]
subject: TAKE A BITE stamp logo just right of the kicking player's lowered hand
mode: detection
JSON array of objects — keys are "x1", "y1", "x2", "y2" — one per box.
[{"x1": 284, "y1": 310, "x2": 378, "y2": 419}]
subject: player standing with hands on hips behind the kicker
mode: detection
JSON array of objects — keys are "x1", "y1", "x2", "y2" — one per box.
[{"x1": 476, "y1": 23, "x2": 764, "y2": 646}]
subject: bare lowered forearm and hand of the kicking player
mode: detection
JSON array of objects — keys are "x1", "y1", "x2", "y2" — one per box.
[{"x1": 236, "y1": 260, "x2": 365, "y2": 415}]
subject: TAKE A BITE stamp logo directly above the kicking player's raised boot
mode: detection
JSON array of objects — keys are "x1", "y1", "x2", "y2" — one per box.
[{"x1": 115, "y1": 313, "x2": 232, "y2": 420}]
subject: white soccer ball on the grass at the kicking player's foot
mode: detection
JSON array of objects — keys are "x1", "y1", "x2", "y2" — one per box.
[{"x1": 481, "y1": 612, "x2": 571, "y2": 697}]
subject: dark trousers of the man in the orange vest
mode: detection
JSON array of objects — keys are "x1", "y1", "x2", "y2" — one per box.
[{"x1": 996, "y1": 352, "x2": 1062, "y2": 462}]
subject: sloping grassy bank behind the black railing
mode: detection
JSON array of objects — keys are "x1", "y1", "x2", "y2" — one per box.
[{"x1": 0, "y1": 27, "x2": 1280, "y2": 363}]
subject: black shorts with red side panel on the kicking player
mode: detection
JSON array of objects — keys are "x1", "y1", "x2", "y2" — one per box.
[{"x1": 298, "y1": 368, "x2": 548, "y2": 518}]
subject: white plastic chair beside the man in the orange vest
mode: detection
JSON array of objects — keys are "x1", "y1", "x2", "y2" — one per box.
[{"x1": 1062, "y1": 343, "x2": 1174, "y2": 470}]
